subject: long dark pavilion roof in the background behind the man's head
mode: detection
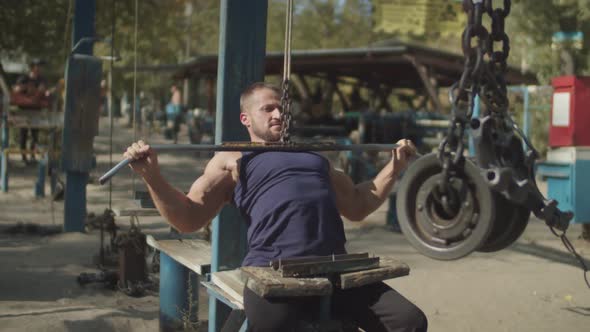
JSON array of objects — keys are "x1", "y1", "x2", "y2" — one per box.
[{"x1": 174, "y1": 42, "x2": 537, "y2": 89}]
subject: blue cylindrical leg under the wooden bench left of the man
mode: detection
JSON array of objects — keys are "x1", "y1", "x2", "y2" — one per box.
[{"x1": 160, "y1": 251, "x2": 200, "y2": 331}]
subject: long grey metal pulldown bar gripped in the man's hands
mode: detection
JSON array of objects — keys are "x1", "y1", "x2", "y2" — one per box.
[{"x1": 98, "y1": 142, "x2": 397, "y2": 184}]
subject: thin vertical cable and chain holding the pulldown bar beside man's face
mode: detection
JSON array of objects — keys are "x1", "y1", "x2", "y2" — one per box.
[{"x1": 281, "y1": 0, "x2": 293, "y2": 143}]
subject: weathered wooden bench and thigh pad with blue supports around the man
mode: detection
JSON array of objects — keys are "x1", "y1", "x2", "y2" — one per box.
[{"x1": 126, "y1": 197, "x2": 410, "y2": 332}]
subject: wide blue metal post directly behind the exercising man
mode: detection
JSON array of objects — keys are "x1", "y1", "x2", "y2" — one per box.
[{"x1": 209, "y1": 0, "x2": 268, "y2": 332}]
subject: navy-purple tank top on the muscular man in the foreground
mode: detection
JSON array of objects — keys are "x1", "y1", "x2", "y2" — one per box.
[{"x1": 234, "y1": 152, "x2": 346, "y2": 266}]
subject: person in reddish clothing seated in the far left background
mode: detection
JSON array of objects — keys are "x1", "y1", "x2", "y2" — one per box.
[{"x1": 13, "y1": 59, "x2": 49, "y2": 164}]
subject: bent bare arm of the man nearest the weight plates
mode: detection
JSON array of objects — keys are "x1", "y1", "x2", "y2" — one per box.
[{"x1": 330, "y1": 139, "x2": 416, "y2": 221}]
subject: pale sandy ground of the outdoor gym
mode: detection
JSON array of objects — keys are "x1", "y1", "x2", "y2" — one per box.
[{"x1": 0, "y1": 119, "x2": 590, "y2": 332}]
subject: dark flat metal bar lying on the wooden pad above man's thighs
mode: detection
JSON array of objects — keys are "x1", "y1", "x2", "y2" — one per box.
[{"x1": 281, "y1": 257, "x2": 379, "y2": 278}]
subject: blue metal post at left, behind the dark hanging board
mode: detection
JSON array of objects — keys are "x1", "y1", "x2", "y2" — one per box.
[{"x1": 63, "y1": 0, "x2": 96, "y2": 232}]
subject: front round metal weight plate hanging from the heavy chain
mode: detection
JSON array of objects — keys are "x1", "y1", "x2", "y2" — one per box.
[{"x1": 396, "y1": 153, "x2": 495, "y2": 260}]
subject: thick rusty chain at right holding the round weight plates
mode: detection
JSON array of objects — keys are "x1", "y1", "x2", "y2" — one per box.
[{"x1": 450, "y1": 0, "x2": 590, "y2": 288}]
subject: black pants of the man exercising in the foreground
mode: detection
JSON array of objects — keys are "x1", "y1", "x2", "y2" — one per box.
[{"x1": 244, "y1": 282, "x2": 428, "y2": 332}]
